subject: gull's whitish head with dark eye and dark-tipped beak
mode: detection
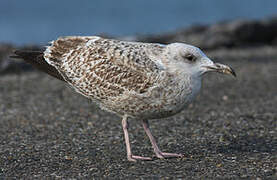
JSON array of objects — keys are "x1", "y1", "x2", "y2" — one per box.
[{"x1": 166, "y1": 43, "x2": 236, "y2": 76}]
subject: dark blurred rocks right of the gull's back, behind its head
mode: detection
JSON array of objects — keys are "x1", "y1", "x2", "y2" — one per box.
[{"x1": 137, "y1": 17, "x2": 277, "y2": 50}]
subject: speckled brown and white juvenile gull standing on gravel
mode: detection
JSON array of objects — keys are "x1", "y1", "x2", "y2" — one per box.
[{"x1": 11, "y1": 36, "x2": 235, "y2": 161}]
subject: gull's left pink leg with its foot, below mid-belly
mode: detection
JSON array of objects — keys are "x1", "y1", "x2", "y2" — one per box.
[{"x1": 122, "y1": 116, "x2": 152, "y2": 161}]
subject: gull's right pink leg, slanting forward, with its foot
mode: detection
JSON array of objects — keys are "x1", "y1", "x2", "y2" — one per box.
[{"x1": 142, "y1": 120, "x2": 183, "y2": 159}]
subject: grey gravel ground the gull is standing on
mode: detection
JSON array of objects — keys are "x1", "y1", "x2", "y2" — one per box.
[{"x1": 0, "y1": 46, "x2": 277, "y2": 179}]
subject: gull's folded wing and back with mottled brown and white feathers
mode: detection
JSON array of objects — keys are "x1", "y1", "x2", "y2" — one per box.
[{"x1": 44, "y1": 36, "x2": 164, "y2": 101}]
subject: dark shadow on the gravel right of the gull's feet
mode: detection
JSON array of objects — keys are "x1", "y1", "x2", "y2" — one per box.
[{"x1": 157, "y1": 135, "x2": 277, "y2": 158}]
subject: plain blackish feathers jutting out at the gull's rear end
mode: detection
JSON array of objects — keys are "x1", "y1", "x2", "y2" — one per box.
[{"x1": 11, "y1": 50, "x2": 64, "y2": 81}]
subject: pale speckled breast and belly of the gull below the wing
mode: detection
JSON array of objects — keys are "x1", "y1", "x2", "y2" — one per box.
[{"x1": 104, "y1": 72, "x2": 201, "y2": 119}]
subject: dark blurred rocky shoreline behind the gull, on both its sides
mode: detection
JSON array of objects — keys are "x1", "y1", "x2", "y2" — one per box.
[{"x1": 0, "y1": 17, "x2": 277, "y2": 74}]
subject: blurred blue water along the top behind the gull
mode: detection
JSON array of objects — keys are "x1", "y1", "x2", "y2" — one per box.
[{"x1": 0, "y1": 0, "x2": 277, "y2": 45}]
